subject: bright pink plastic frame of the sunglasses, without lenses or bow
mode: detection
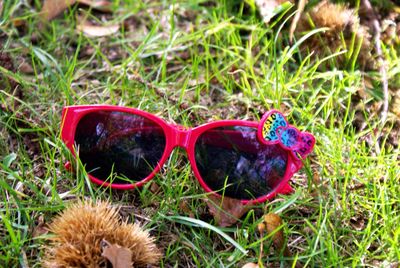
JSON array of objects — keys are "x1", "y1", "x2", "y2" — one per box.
[{"x1": 61, "y1": 105, "x2": 303, "y2": 204}]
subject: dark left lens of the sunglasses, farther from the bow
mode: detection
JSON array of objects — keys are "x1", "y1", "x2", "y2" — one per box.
[{"x1": 75, "y1": 111, "x2": 166, "y2": 183}]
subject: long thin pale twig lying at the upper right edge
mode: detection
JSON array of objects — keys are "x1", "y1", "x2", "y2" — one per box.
[{"x1": 362, "y1": 0, "x2": 389, "y2": 124}]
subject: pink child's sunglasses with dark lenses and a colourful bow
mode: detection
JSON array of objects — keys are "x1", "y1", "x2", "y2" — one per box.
[{"x1": 61, "y1": 105, "x2": 315, "y2": 204}]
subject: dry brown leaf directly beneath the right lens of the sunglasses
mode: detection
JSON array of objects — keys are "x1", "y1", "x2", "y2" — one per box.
[{"x1": 207, "y1": 195, "x2": 250, "y2": 227}]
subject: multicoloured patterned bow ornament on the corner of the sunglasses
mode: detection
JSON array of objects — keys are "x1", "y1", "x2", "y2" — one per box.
[{"x1": 257, "y1": 110, "x2": 315, "y2": 160}]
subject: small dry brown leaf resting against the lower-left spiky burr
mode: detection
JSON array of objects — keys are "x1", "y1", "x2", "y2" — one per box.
[{"x1": 101, "y1": 239, "x2": 133, "y2": 268}]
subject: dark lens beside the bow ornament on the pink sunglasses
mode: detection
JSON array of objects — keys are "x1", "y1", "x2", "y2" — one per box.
[{"x1": 195, "y1": 126, "x2": 288, "y2": 200}]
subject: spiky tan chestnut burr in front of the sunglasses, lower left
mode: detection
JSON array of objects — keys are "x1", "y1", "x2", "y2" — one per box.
[{"x1": 42, "y1": 201, "x2": 161, "y2": 268}]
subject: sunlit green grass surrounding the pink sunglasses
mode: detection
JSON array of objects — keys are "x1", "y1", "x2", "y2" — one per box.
[{"x1": 0, "y1": 0, "x2": 400, "y2": 267}]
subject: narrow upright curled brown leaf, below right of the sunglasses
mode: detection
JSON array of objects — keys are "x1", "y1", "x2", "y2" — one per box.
[{"x1": 264, "y1": 213, "x2": 291, "y2": 257}]
